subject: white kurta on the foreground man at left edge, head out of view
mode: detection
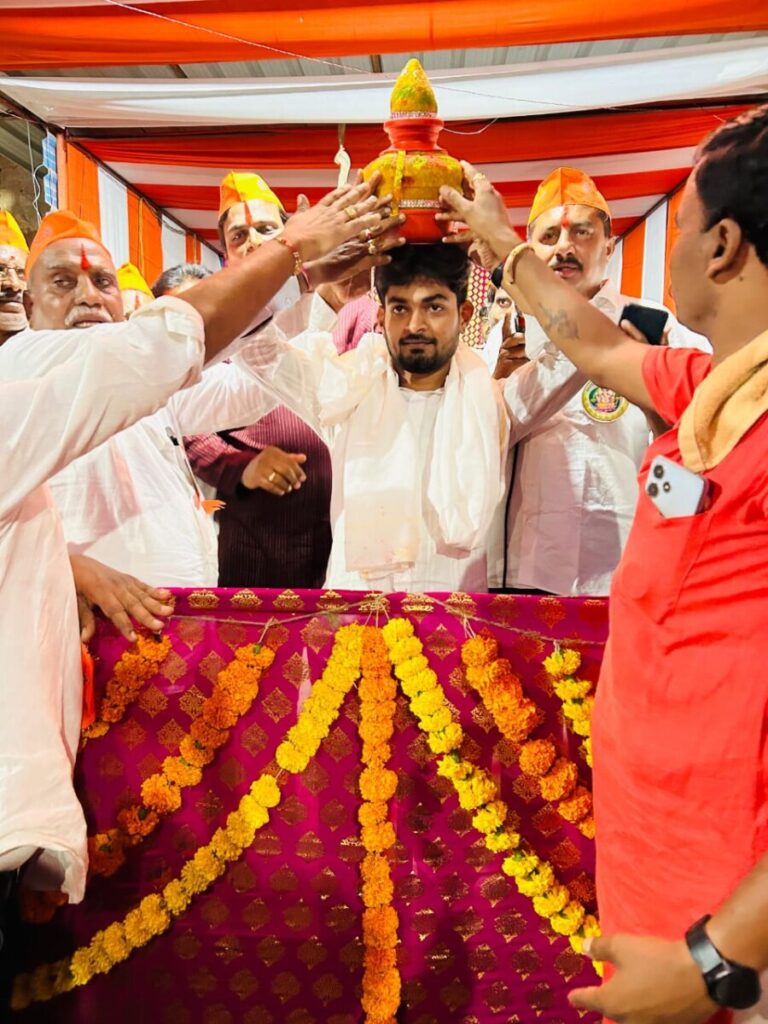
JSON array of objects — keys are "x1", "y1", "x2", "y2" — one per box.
[{"x1": 0, "y1": 299, "x2": 204, "y2": 901}]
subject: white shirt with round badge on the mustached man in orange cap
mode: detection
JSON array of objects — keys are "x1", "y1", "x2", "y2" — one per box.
[{"x1": 489, "y1": 283, "x2": 707, "y2": 595}]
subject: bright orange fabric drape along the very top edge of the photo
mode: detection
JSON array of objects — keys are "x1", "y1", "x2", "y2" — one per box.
[{"x1": 0, "y1": 0, "x2": 768, "y2": 71}]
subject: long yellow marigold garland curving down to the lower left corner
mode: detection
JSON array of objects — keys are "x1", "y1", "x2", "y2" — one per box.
[{"x1": 11, "y1": 625, "x2": 361, "y2": 1010}]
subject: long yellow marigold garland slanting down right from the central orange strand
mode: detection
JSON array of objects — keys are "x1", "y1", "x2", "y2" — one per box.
[{"x1": 382, "y1": 618, "x2": 599, "y2": 949}]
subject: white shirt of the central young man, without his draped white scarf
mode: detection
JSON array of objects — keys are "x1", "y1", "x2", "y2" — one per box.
[{"x1": 234, "y1": 317, "x2": 581, "y2": 593}]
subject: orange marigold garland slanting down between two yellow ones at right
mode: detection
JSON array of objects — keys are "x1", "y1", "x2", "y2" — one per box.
[{"x1": 462, "y1": 633, "x2": 595, "y2": 839}]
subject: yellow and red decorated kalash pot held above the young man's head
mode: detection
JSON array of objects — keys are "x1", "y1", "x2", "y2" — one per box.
[{"x1": 362, "y1": 59, "x2": 463, "y2": 242}]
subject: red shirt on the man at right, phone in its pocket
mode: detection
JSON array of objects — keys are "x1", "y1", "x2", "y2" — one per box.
[{"x1": 593, "y1": 348, "x2": 768, "y2": 1020}]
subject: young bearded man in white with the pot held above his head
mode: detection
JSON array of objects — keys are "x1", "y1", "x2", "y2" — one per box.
[{"x1": 236, "y1": 245, "x2": 579, "y2": 592}]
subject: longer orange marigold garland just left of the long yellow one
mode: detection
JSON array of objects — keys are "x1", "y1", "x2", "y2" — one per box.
[{"x1": 88, "y1": 644, "x2": 274, "y2": 878}]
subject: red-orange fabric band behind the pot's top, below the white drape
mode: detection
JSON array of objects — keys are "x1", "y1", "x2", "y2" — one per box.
[{"x1": 82, "y1": 104, "x2": 749, "y2": 172}]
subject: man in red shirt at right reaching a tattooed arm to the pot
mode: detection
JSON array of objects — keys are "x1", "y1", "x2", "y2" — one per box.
[{"x1": 442, "y1": 105, "x2": 768, "y2": 1024}]
